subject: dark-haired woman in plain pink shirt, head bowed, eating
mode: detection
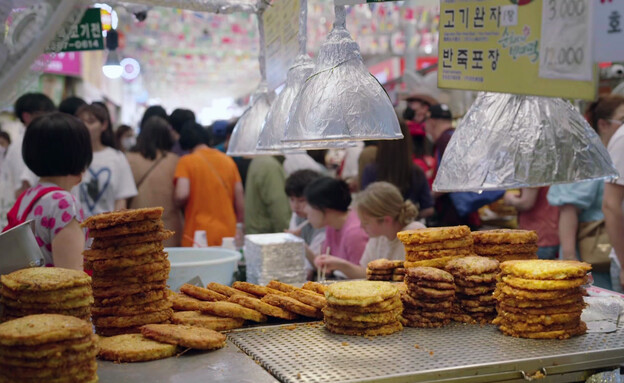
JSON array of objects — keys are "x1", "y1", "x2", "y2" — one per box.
[{"x1": 304, "y1": 177, "x2": 368, "y2": 271}]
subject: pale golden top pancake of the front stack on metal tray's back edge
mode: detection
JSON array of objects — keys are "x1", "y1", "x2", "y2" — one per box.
[{"x1": 325, "y1": 281, "x2": 399, "y2": 306}]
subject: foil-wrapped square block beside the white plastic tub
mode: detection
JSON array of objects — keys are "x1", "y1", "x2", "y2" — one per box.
[{"x1": 244, "y1": 233, "x2": 306, "y2": 285}]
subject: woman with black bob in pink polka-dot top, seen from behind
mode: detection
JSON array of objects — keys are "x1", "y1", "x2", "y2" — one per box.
[{"x1": 9, "y1": 113, "x2": 93, "y2": 270}]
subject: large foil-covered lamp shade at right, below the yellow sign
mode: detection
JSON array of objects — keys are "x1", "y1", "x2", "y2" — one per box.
[{"x1": 433, "y1": 93, "x2": 618, "y2": 192}]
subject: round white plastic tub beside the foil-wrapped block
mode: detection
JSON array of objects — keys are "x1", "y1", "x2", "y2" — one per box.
[{"x1": 165, "y1": 247, "x2": 241, "y2": 291}]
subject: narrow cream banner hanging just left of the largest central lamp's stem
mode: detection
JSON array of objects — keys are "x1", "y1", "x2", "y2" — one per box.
[{"x1": 262, "y1": 0, "x2": 299, "y2": 90}]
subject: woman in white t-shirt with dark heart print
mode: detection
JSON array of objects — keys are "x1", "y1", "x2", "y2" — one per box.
[{"x1": 74, "y1": 103, "x2": 137, "y2": 217}]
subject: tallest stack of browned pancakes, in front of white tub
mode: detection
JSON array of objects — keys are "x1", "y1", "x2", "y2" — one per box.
[{"x1": 82, "y1": 208, "x2": 173, "y2": 336}]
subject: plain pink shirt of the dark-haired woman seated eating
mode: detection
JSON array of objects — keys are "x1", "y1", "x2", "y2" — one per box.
[{"x1": 321, "y1": 210, "x2": 368, "y2": 265}]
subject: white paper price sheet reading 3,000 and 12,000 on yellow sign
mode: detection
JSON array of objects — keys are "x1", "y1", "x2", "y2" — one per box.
[{"x1": 539, "y1": 0, "x2": 592, "y2": 81}]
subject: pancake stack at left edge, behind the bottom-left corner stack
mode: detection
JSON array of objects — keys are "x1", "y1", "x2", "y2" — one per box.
[{"x1": 0, "y1": 267, "x2": 93, "y2": 321}]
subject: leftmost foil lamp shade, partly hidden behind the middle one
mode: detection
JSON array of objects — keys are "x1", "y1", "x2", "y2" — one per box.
[{"x1": 227, "y1": 82, "x2": 280, "y2": 157}]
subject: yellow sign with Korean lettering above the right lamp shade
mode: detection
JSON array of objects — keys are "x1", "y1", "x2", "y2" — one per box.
[{"x1": 438, "y1": 0, "x2": 597, "y2": 100}]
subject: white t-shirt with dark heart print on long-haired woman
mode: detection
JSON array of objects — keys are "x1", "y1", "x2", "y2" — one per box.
[{"x1": 72, "y1": 148, "x2": 137, "y2": 218}]
